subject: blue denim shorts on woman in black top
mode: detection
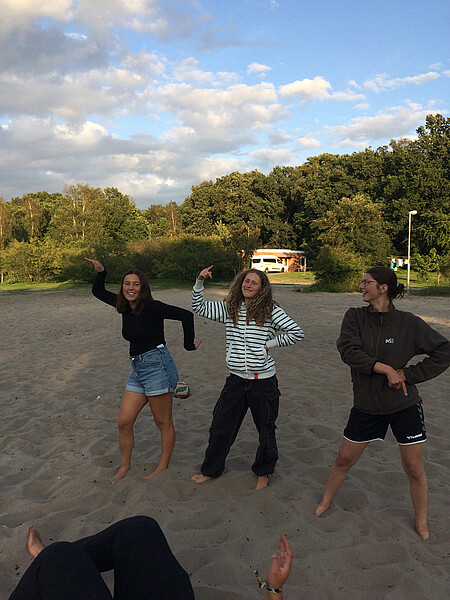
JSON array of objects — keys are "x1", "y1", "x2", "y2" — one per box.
[{"x1": 125, "y1": 346, "x2": 178, "y2": 396}]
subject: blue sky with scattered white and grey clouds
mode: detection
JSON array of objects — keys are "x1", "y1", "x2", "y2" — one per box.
[{"x1": 0, "y1": 0, "x2": 450, "y2": 209}]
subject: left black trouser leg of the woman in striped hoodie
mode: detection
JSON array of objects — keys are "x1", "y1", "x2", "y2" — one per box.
[{"x1": 201, "y1": 375, "x2": 248, "y2": 477}]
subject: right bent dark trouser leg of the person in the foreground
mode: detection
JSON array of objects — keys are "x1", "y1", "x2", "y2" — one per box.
[{"x1": 75, "y1": 516, "x2": 194, "y2": 600}]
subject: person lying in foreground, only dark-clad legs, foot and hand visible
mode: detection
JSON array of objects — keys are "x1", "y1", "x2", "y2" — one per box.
[{"x1": 9, "y1": 516, "x2": 293, "y2": 600}]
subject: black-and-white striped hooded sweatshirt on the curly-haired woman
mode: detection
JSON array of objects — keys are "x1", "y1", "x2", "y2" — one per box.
[{"x1": 192, "y1": 279, "x2": 304, "y2": 379}]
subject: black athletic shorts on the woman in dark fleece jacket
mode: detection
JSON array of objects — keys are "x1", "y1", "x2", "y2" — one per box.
[{"x1": 344, "y1": 402, "x2": 427, "y2": 446}]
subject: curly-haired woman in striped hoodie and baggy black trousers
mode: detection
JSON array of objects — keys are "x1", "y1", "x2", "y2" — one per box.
[{"x1": 192, "y1": 265, "x2": 304, "y2": 490}]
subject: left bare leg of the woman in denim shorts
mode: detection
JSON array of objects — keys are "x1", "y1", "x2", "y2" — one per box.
[{"x1": 111, "y1": 390, "x2": 147, "y2": 485}]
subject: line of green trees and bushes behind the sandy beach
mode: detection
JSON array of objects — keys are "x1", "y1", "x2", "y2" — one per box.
[{"x1": 0, "y1": 114, "x2": 450, "y2": 288}]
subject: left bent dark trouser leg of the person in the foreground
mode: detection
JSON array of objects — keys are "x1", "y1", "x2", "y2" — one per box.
[{"x1": 10, "y1": 542, "x2": 112, "y2": 600}]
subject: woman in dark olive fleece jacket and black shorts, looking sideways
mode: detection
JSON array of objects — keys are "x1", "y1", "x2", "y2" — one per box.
[{"x1": 316, "y1": 267, "x2": 450, "y2": 540}]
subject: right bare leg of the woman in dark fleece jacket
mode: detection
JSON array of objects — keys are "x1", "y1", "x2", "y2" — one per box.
[{"x1": 400, "y1": 444, "x2": 430, "y2": 540}]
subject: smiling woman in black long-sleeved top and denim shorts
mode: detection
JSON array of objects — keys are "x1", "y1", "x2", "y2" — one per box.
[{"x1": 85, "y1": 258, "x2": 200, "y2": 485}]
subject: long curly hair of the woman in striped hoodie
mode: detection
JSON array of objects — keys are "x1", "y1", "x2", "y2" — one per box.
[{"x1": 225, "y1": 269, "x2": 276, "y2": 327}]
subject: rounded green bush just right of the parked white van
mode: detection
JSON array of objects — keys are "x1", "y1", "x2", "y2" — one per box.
[{"x1": 310, "y1": 246, "x2": 365, "y2": 292}]
